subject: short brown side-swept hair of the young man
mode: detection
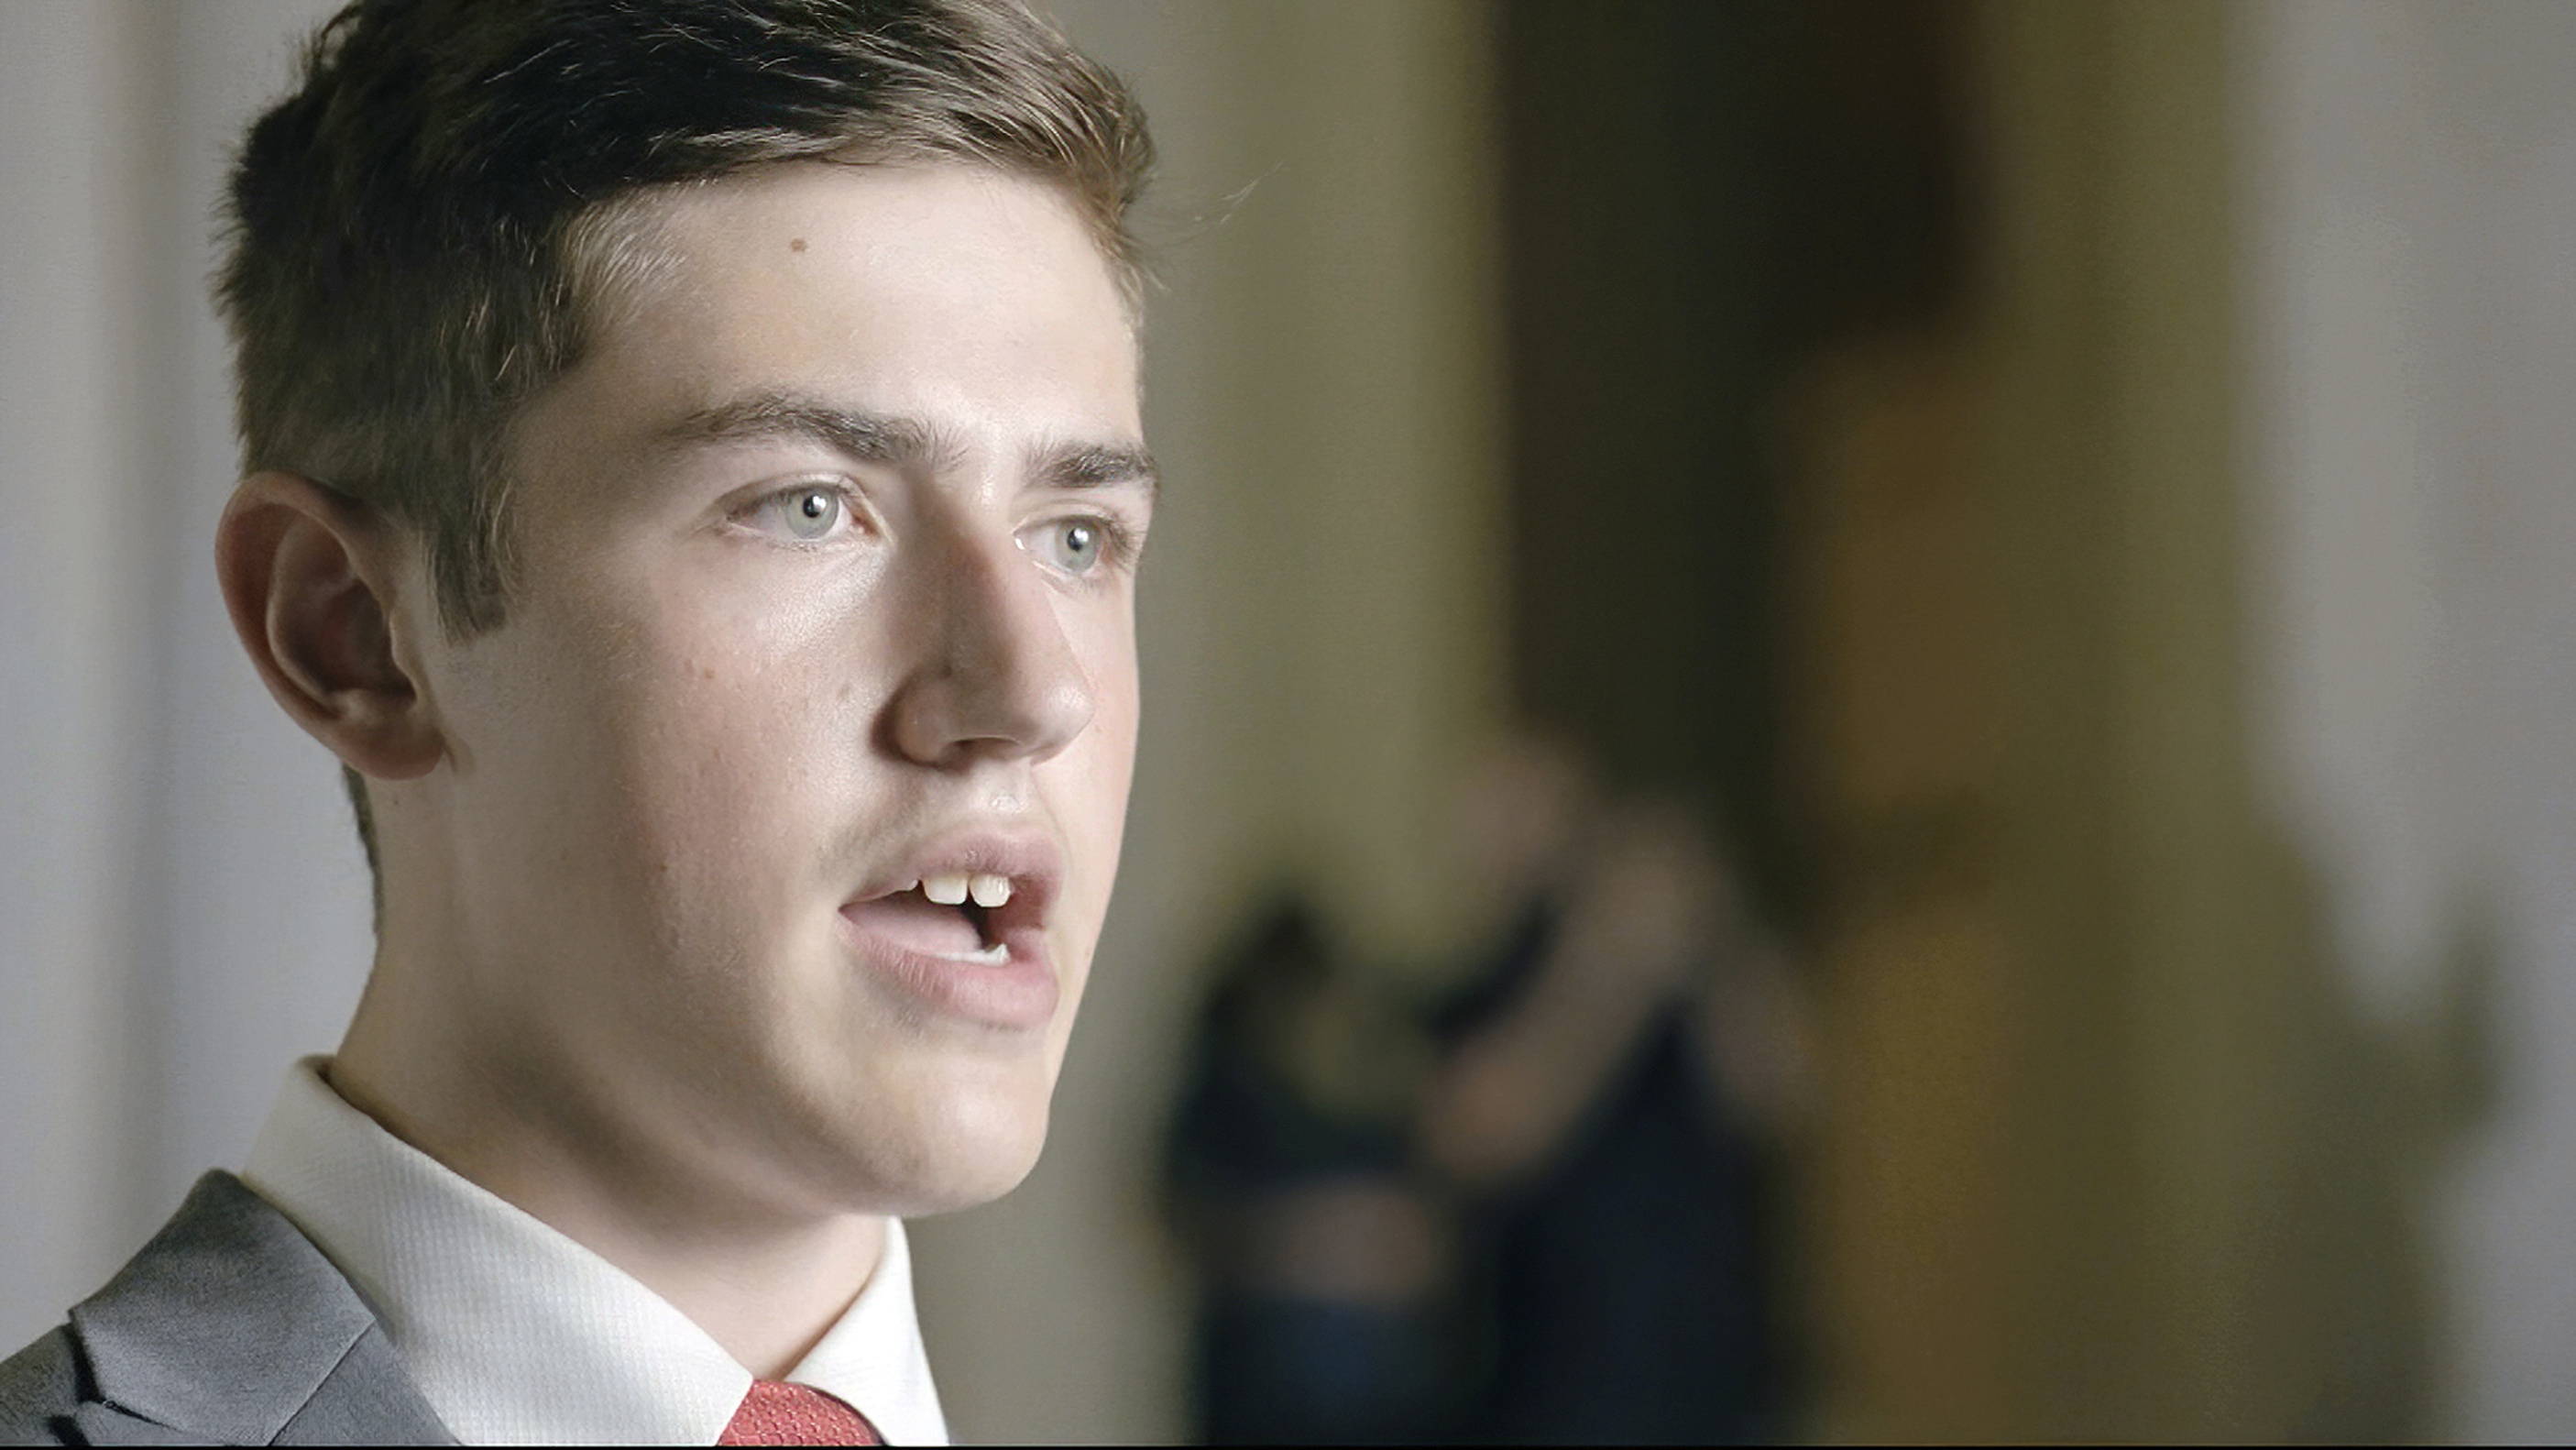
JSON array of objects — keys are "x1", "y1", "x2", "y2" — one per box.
[{"x1": 216, "y1": 0, "x2": 1154, "y2": 906}]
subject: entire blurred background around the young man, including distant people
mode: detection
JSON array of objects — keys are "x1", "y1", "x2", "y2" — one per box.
[{"x1": 0, "y1": 0, "x2": 2576, "y2": 1440}]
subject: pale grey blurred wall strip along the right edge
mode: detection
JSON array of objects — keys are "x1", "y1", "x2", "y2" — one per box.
[{"x1": 2233, "y1": 0, "x2": 2576, "y2": 1443}]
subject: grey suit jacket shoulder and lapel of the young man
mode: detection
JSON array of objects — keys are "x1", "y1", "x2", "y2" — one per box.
[{"x1": 0, "y1": 1172, "x2": 456, "y2": 1445}]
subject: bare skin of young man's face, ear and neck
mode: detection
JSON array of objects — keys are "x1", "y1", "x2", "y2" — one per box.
[{"x1": 219, "y1": 162, "x2": 1154, "y2": 1373}]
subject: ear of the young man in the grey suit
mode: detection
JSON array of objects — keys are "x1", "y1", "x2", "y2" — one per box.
[{"x1": 214, "y1": 471, "x2": 445, "y2": 780}]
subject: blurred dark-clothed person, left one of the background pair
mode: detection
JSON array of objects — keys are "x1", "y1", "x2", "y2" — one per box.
[{"x1": 1169, "y1": 894, "x2": 1455, "y2": 1445}]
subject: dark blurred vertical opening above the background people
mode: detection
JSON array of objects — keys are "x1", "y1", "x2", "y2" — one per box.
[{"x1": 1496, "y1": 0, "x2": 1973, "y2": 922}]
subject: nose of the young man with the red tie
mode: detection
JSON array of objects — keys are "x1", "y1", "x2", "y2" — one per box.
[{"x1": 886, "y1": 528, "x2": 1095, "y2": 770}]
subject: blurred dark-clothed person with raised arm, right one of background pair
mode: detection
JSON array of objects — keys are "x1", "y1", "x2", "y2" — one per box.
[{"x1": 1420, "y1": 741, "x2": 1808, "y2": 1443}]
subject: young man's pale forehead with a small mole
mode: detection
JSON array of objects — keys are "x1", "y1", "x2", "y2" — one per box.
[{"x1": 565, "y1": 162, "x2": 1141, "y2": 463}]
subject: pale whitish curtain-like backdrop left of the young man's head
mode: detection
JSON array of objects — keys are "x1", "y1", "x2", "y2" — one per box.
[{"x1": 0, "y1": 0, "x2": 368, "y2": 1352}]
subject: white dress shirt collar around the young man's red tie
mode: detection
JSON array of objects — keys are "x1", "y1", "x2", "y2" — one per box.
[{"x1": 242, "y1": 1059, "x2": 948, "y2": 1445}]
